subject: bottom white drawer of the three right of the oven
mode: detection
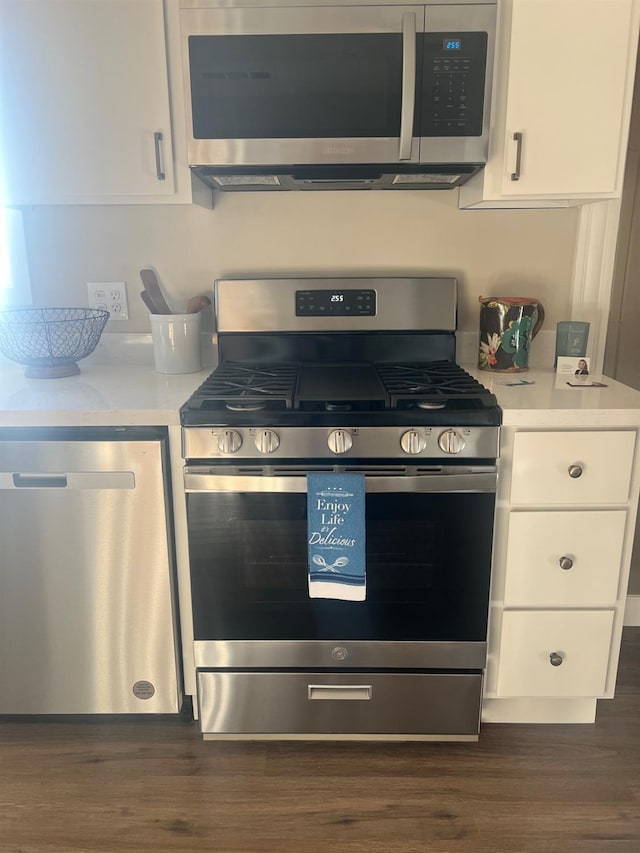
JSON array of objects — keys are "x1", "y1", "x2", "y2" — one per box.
[{"x1": 497, "y1": 610, "x2": 614, "y2": 697}]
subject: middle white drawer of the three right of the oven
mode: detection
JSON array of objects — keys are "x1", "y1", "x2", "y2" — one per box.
[{"x1": 504, "y1": 510, "x2": 627, "y2": 607}]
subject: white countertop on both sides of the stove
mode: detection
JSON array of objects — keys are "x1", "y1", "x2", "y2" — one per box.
[{"x1": 0, "y1": 334, "x2": 640, "y2": 427}]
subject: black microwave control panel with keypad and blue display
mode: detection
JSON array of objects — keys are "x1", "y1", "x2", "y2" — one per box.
[{"x1": 419, "y1": 32, "x2": 487, "y2": 136}]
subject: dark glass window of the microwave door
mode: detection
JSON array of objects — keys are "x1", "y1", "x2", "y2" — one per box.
[{"x1": 189, "y1": 33, "x2": 402, "y2": 139}]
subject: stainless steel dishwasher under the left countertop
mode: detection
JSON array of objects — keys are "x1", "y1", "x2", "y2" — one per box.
[{"x1": 0, "y1": 427, "x2": 182, "y2": 714}]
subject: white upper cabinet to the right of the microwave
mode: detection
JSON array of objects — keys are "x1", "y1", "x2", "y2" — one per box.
[{"x1": 460, "y1": 0, "x2": 638, "y2": 207}]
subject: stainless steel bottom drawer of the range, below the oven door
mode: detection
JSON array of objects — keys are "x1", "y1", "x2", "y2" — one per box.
[{"x1": 198, "y1": 670, "x2": 482, "y2": 740}]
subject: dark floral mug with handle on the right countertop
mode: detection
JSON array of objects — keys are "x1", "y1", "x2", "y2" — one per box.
[{"x1": 478, "y1": 296, "x2": 544, "y2": 373}]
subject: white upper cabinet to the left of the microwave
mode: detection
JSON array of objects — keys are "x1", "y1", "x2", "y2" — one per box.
[{"x1": 0, "y1": 0, "x2": 206, "y2": 205}]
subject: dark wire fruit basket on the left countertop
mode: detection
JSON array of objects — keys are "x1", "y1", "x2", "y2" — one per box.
[{"x1": 0, "y1": 308, "x2": 109, "y2": 379}]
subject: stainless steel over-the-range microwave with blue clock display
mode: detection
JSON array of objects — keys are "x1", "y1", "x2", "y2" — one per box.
[{"x1": 180, "y1": 0, "x2": 496, "y2": 190}]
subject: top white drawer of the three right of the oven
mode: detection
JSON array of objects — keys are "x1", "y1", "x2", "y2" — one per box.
[{"x1": 511, "y1": 430, "x2": 636, "y2": 504}]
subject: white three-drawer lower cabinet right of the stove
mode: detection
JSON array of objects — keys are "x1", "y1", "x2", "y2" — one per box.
[{"x1": 483, "y1": 427, "x2": 639, "y2": 722}]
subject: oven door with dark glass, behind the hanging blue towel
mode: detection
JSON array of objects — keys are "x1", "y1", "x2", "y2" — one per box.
[{"x1": 185, "y1": 465, "x2": 496, "y2": 668}]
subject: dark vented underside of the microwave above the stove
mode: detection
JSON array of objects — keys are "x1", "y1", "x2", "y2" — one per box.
[{"x1": 191, "y1": 163, "x2": 483, "y2": 192}]
